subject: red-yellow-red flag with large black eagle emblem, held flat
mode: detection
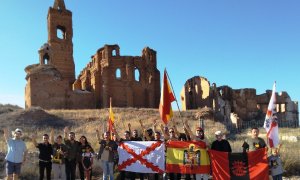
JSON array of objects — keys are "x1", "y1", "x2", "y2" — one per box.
[{"x1": 166, "y1": 141, "x2": 210, "y2": 174}]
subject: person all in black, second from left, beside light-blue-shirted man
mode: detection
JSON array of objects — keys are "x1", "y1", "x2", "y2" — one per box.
[{"x1": 32, "y1": 134, "x2": 53, "y2": 180}]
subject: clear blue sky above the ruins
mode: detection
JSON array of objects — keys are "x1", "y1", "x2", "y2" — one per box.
[{"x1": 0, "y1": 0, "x2": 300, "y2": 107}]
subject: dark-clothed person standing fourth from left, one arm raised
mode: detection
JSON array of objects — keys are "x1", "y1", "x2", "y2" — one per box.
[{"x1": 64, "y1": 127, "x2": 80, "y2": 180}]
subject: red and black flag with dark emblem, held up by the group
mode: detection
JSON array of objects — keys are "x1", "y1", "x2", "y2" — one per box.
[{"x1": 209, "y1": 148, "x2": 269, "y2": 180}]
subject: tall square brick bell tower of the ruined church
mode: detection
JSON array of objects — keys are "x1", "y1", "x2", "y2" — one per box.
[{"x1": 47, "y1": 0, "x2": 75, "y2": 87}]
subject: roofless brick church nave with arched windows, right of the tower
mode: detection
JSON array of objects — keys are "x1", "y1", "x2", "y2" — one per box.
[{"x1": 73, "y1": 45, "x2": 160, "y2": 108}]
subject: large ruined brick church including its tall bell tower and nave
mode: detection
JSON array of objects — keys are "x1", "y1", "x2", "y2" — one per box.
[{"x1": 25, "y1": 0, "x2": 160, "y2": 109}]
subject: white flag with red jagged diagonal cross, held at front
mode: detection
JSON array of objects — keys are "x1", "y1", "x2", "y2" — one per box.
[{"x1": 118, "y1": 141, "x2": 165, "y2": 173}]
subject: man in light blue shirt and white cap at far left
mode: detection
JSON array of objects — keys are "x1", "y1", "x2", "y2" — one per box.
[{"x1": 3, "y1": 128, "x2": 27, "y2": 180}]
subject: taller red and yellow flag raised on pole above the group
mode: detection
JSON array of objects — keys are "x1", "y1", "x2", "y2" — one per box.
[{"x1": 159, "y1": 69, "x2": 175, "y2": 124}]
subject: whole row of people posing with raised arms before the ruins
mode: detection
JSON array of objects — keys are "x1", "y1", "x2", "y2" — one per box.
[{"x1": 4, "y1": 121, "x2": 283, "y2": 180}]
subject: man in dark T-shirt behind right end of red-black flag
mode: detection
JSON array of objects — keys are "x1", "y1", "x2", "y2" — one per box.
[{"x1": 242, "y1": 127, "x2": 266, "y2": 152}]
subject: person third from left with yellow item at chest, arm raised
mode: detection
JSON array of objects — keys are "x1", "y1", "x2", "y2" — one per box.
[{"x1": 50, "y1": 130, "x2": 67, "y2": 180}]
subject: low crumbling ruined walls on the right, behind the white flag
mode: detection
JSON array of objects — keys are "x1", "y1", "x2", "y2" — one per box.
[{"x1": 180, "y1": 76, "x2": 299, "y2": 124}]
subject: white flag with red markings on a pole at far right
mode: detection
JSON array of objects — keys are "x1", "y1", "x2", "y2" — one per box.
[{"x1": 264, "y1": 82, "x2": 279, "y2": 148}]
